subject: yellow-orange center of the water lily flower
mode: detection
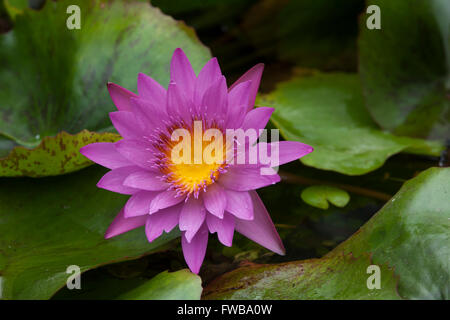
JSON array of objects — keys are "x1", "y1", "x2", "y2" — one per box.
[{"x1": 156, "y1": 121, "x2": 226, "y2": 198}]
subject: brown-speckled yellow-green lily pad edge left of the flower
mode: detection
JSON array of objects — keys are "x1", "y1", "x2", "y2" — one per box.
[{"x1": 0, "y1": 130, "x2": 122, "y2": 177}]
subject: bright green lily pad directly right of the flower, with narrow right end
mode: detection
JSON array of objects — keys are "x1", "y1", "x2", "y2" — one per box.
[{"x1": 257, "y1": 72, "x2": 443, "y2": 175}]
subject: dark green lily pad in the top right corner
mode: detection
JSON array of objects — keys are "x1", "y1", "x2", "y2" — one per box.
[{"x1": 359, "y1": 0, "x2": 450, "y2": 139}]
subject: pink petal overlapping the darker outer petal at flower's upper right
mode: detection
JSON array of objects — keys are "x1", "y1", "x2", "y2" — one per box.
[{"x1": 226, "y1": 81, "x2": 252, "y2": 129}]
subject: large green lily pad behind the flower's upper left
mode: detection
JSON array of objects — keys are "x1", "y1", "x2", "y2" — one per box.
[{"x1": 0, "y1": 0, "x2": 210, "y2": 147}]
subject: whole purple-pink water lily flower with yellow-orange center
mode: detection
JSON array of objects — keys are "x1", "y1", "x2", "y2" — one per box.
[{"x1": 80, "y1": 49, "x2": 313, "y2": 273}]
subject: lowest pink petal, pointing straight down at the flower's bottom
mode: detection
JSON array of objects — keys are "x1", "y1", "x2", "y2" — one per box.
[{"x1": 181, "y1": 224, "x2": 208, "y2": 274}]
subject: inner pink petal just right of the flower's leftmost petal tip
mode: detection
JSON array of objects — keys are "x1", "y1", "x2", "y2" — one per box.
[{"x1": 114, "y1": 139, "x2": 154, "y2": 170}]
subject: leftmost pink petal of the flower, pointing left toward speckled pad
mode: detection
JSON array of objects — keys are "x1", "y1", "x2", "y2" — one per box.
[{"x1": 80, "y1": 142, "x2": 132, "y2": 169}]
